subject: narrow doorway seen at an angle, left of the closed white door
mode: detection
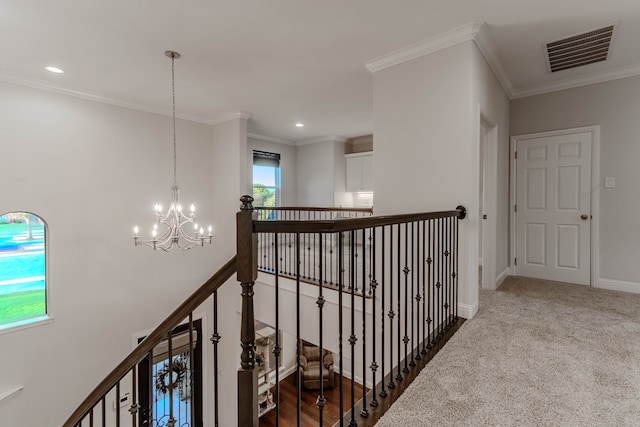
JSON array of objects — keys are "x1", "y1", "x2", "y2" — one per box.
[{"x1": 478, "y1": 115, "x2": 498, "y2": 289}]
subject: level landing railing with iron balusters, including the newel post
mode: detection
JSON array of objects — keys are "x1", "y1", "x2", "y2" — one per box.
[{"x1": 238, "y1": 197, "x2": 466, "y2": 427}]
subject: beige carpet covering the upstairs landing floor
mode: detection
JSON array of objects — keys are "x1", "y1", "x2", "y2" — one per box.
[{"x1": 376, "y1": 277, "x2": 640, "y2": 427}]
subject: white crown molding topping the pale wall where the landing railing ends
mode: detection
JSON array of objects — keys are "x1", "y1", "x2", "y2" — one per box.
[{"x1": 365, "y1": 22, "x2": 485, "y2": 73}]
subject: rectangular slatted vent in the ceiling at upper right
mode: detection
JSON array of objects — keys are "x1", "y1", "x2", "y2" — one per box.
[{"x1": 545, "y1": 24, "x2": 616, "y2": 73}]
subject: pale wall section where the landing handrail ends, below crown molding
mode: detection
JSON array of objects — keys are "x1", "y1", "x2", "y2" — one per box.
[{"x1": 373, "y1": 42, "x2": 478, "y2": 314}]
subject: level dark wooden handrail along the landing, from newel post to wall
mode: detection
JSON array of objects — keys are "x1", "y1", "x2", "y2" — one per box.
[{"x1": 253, "y1": 206, "x2": 466, "y2": 233}]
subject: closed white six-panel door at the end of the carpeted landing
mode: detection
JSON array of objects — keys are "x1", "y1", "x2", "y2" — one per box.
[{"x1": 515, "y1": 132, "x2": 593, "y2": 285}]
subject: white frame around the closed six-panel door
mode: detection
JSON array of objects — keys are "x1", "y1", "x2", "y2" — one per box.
[{"x1": 509, "y1": 125, "x2": 600, "y2": 287}]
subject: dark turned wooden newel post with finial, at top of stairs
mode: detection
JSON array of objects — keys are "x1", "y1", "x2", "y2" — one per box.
[{"x1": 236, "y1": 195, "x2": 258, "y2": 427}]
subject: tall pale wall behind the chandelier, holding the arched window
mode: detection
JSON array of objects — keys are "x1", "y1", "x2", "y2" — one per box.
[{"x1": 0, "y1": 83, "x2": 246, "y2": 427}]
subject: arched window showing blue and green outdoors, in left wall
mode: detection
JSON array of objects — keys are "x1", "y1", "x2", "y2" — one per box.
[{"x1": 0, "y1": 212, "x2": 47, "y2": 329}]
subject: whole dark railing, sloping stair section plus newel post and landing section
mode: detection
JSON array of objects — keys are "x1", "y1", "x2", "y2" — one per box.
[{"x1": 64, "y1": 196, "x2": 466, "y2": 427}]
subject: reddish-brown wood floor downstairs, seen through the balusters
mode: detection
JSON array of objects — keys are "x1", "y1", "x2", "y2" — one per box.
[{"x1": 260, "y1": 373, "x2": 368, "y2": 427}]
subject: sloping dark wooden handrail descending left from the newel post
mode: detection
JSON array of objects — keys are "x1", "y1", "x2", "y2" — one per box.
[{"x1": 63, "y1": 256, "x2": 236, "y2": 427}]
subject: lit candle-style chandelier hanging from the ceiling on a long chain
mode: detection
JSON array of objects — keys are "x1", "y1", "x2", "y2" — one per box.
[{"x1": 133, "y1": 50, "x2": 213, "y2": 252}]
